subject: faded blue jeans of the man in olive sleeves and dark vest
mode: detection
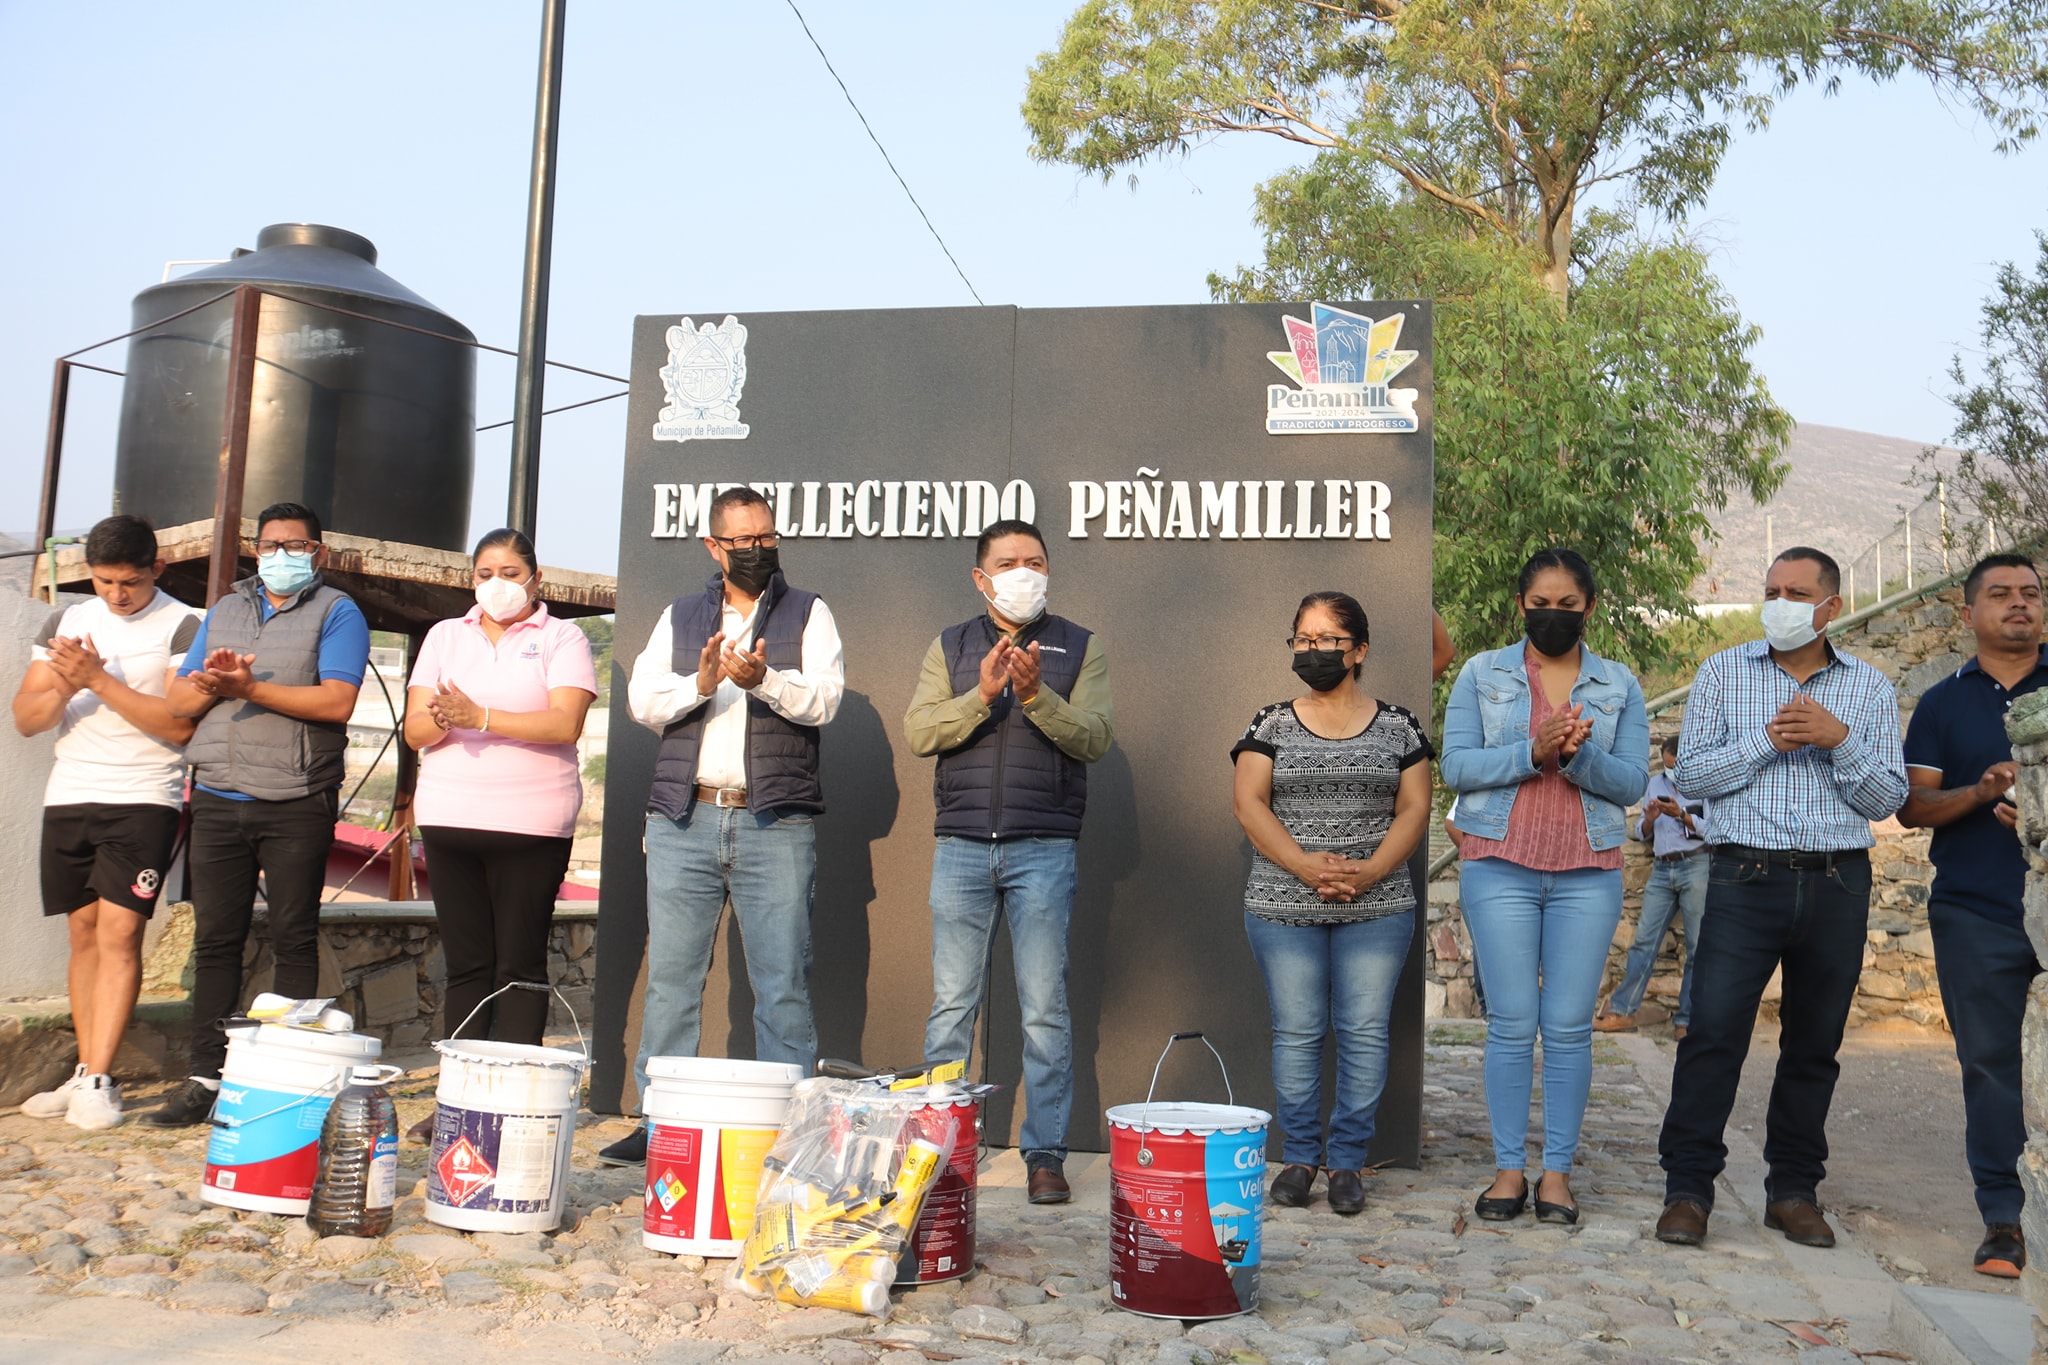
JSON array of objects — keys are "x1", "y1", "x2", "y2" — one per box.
[{"x1": 924, "y1": 835, "x2": 1075, "y2": 1162}]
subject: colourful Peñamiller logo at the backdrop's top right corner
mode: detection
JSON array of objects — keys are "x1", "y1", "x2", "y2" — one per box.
[{"x1": 1269, "y1": 303, "x2": 1419, "y2": 436}]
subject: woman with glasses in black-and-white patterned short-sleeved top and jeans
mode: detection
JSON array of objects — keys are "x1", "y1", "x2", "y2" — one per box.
[{"x1": 1231, "y1": 591, "x2": 1432, "y2": 1214}]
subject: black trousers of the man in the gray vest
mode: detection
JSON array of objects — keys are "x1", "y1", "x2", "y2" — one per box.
[{"x1": 188, "y1": 790, "x2": 340, "y2": 1076}]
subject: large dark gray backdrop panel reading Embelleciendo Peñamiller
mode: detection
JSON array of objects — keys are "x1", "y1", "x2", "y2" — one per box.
[{"x1": 592, "y1": 303, "x2": 1434, "y2": 1164}]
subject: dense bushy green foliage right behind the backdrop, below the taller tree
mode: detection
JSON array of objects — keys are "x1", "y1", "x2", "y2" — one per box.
[{"x1": 1210, "y1": 149, "x2": 1792, "y2": 665}]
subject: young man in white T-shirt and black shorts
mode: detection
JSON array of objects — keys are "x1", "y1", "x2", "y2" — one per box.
[{"x1": 14, "y1": 516, "x2": 199, "y2": 1130}]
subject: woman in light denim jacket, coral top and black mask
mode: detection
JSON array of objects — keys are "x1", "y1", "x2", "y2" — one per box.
[{"x1": 1444, "y1": 548, "x2": 1651, "y2": 1224}]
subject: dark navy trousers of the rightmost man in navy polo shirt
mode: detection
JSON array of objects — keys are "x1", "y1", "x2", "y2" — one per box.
[{"x1": 1927, "y1": 900, "x2": 2042, "y2": 1224}]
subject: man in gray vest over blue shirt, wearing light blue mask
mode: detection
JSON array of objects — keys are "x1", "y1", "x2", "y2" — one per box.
[{"x1": 147, "y1": 501, "x2": 371, "y2": 1128}]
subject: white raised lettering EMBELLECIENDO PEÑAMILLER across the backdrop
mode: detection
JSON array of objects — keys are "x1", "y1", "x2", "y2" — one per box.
[{"x1": 649, "y1": 469, "x2": 1393, "y2": 540}]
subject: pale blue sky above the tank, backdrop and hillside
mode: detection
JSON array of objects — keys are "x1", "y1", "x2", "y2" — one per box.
[{"x1": 0, "y1": 0, "x2": 2048, "y2": 571}]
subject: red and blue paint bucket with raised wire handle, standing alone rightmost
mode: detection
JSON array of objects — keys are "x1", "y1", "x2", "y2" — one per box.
[{"x1": 1106, "y1": 1033, "x2": 1272, "y2": 1320}]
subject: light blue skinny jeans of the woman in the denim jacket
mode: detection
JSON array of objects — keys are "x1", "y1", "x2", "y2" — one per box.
[{"x1": 1458, "y1": 857, "x2": 1622, "y2": 1175}]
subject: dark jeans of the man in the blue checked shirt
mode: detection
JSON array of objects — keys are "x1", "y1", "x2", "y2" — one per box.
[{"x1": 1657, "y1": 849, "x2": 1870, "y2": 1207}]
